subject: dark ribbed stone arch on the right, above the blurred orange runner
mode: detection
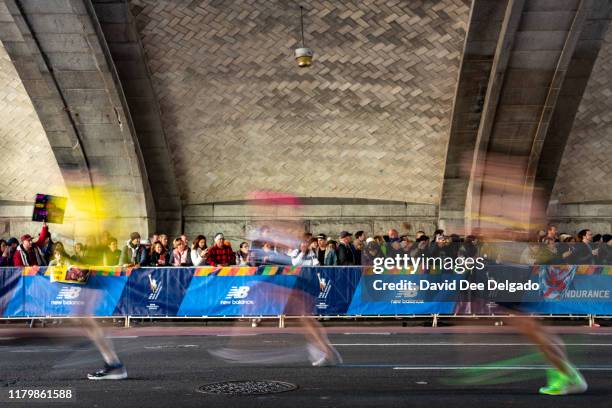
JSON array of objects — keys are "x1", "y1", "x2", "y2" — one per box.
[{"x1": 440, "y1": 0, "x2": 612, "y2": 234}]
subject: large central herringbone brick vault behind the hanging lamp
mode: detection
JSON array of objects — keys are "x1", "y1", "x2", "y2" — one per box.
[{"x1": 130, "y1": 0, "x2": 470, "y2": 204}]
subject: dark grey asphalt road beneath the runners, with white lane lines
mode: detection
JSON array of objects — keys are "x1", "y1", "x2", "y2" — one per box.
[{"x1": 0, "y1": 327, "x2": 612, "y2": 408}]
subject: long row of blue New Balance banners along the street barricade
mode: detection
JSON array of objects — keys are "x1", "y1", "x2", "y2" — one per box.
[{"x1": 0, "y1": 265, "x2": 612, "y2": 317}]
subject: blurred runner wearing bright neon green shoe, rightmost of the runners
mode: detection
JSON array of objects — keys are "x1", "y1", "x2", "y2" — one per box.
[{"x1": 468, "y1": 153, "x2": 588, "y2": 395}]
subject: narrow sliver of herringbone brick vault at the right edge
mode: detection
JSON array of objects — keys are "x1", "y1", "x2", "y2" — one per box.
[{"x1": 553, "y1": 28, "x2": 612, "y2": 203}]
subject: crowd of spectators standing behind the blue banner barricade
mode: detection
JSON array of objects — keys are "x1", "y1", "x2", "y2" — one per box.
[{"x1": 0, "y1": 223, "x2": 612, "y2": 267}]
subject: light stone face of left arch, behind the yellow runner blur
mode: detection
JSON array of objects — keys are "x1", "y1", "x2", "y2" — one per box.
[{"x1": 0, "y1": 0, "x2": 155, "y2": 241}]
